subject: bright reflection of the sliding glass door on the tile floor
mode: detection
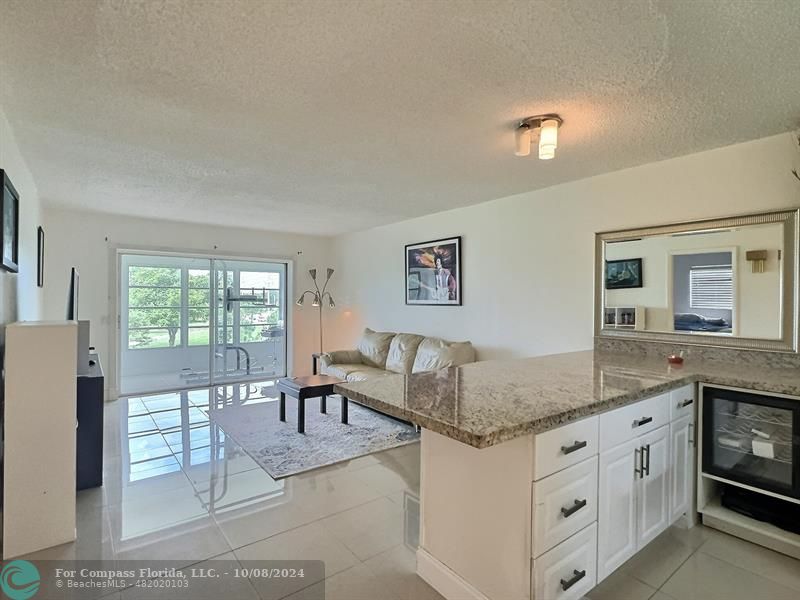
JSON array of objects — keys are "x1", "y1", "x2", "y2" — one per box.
[{"x1": 119, "y1": 381, "x2": 286, "y2": 540}]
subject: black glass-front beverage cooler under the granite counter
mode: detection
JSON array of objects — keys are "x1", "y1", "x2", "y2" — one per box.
[{"x1": 703, "y1": 387, "x2": 800, "y2": 499}]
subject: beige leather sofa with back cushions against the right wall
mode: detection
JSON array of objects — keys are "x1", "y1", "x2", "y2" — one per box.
[{"x1": 320, "y1": 329, "x2": 475, "y2": 381}]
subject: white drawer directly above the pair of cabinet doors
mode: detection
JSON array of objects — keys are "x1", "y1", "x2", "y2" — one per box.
[{"x1": 600, "y1": 392, "x2": 670, "y2": 452}]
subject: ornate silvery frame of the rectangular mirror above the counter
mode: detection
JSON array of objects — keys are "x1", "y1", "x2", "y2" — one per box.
[{"x1": 594, "y1": 208, "x2": 800, "y2": 352}]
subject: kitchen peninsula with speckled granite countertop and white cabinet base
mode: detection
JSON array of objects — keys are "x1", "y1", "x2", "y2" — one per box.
[{"x1": 335, "y1": 351, "x2": 800, "y2": 600}]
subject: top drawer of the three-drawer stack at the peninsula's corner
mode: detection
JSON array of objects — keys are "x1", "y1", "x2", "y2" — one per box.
[{"x1": 533, "y1": 416, "x2": 598, "y2": 481}]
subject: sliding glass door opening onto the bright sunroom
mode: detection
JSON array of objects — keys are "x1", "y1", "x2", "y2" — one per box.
[{"x1": 119, "y1": 252, "x2": 287, "y2": 395}]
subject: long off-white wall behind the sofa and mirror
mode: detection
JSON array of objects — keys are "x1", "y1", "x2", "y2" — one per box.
[{"x1": 335, "y1": 134, "x2": 800, "y2": 359}]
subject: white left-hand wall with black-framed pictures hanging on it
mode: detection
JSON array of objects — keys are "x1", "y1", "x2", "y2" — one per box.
[{"x1": 0, "y1": 108, "x2": 42, "y2": 347}]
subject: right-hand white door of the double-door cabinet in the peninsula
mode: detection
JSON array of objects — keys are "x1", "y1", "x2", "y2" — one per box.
[{"x1": 636, "y1": 426, "x2": 671, "y2": 549}]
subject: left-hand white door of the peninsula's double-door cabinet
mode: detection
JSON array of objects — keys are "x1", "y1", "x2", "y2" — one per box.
[{"x1": 597, "y1": 440, "x2": 640, "y2": 583}]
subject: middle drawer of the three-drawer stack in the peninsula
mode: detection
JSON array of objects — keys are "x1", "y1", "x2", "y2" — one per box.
[{"x1": 532, "y1": 456, "x2": 597, "y2": 557}]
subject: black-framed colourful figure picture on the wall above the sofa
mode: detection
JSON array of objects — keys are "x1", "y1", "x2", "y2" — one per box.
[{"x1": 406, "y1": 236, "x2": 461, "y2": 306}]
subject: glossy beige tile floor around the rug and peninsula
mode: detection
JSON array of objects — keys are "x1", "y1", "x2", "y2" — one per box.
[{"x1": 18, "y1": 384, "x2": 800, "y2": 600}]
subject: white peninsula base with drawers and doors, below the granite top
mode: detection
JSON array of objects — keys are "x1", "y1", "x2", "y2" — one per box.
[{"x1": 417, "y1": 385, "x2": 696, "y2": 600}]
